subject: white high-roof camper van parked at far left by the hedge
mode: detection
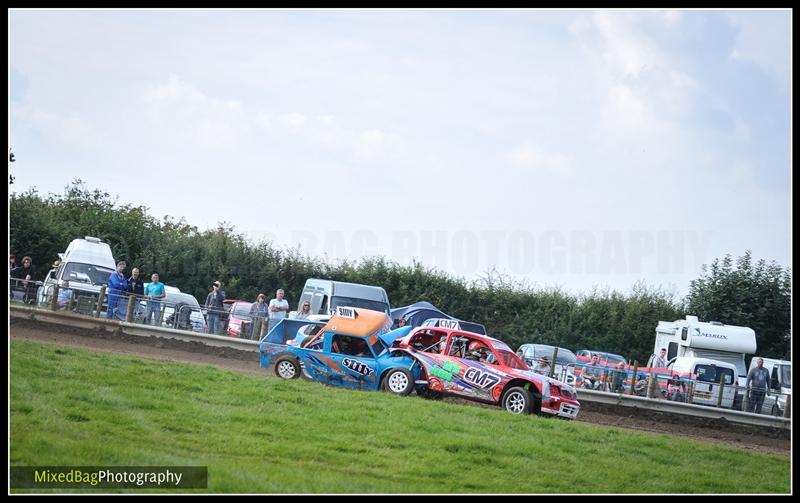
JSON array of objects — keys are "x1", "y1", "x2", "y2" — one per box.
[{"x1": 36, "y1": 236, "x2": 117, "y2": 304}]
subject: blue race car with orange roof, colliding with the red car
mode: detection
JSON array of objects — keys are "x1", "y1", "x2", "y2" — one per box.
[{"x1": 259, "y1": 307, "x2": 420, "y2": 395}]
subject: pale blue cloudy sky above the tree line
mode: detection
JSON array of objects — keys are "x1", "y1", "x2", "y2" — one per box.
[{"x1": 8, "y1": 9, "x2": 791, "y2": 295}]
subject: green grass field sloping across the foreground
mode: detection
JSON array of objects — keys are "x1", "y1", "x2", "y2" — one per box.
[{"x1": 10, "y1": 341, "x2": 790, "y2": 493}]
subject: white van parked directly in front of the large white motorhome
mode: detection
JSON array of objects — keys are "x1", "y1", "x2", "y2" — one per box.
[{"x1": 667, "y1": 356, "x2": 737, "y2": 409}]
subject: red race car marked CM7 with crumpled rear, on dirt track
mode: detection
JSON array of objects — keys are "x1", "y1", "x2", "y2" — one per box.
[{"x1": 393, "y1": 327, "x2": 580, "y2": 419}]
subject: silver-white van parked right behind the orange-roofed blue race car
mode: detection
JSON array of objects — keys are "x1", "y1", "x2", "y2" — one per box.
[{"x1": 297, "y1": 278, "x2": 390, "y2": 316}]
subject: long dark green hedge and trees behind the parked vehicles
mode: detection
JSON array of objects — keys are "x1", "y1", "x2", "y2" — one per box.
[{"x1": 9, "y1": 180, "x2": 791, "y2": 363}]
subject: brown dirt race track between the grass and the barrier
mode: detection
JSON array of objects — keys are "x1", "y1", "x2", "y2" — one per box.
[{"x1": 10, "y1": 319, "x2": 791, "y2": 455}]
